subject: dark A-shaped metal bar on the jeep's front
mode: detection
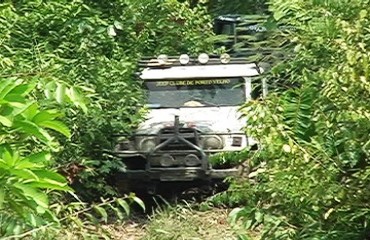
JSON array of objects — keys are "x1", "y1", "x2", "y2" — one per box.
[{"x1": 145, "y1": 115, "x2": 209, "y2": 171}]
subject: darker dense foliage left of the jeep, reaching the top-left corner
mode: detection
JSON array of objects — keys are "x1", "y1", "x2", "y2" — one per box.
[{"x1": 0, "y1": 0, "x2": 212, "y2": 199}]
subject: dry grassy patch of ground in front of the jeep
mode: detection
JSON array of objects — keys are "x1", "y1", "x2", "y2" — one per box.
[{"x1": 106, "y1": 204, "x2": 249, "y2": 240}]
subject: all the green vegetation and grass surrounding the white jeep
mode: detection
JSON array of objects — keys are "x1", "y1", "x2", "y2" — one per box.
[{"x1": 0, "y1": 0, "x2": 370, "y2": 240}]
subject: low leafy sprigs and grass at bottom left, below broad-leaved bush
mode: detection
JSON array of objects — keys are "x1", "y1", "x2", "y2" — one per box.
[{"x1": 2, "y1": 195, "x2": 145, "y2": 240}]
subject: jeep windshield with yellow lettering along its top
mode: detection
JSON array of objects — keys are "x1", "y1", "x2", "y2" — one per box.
[{"x1": 145, "y1": 77, "x2": 245, "y2": 108}]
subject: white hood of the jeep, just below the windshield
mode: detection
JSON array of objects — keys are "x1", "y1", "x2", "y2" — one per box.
[{"x1": 137, "y1": 106, "x2": 246, "y2": 134}]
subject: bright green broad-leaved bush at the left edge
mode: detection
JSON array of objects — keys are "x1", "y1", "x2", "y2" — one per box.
[{"x1": 0, "y1": 78, "x2": 71, "y2": 236}]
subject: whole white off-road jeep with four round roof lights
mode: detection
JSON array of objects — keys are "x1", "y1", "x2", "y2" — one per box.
[{"x1": 114, "y1": 53, "x2": 264, "y2": 193}]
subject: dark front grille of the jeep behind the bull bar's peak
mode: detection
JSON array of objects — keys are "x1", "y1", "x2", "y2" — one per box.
[{"x1": 159, "y1": 127, "x2": 199, "y2": 150}]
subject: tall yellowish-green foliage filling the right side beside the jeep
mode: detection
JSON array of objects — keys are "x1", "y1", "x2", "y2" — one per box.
[{"x1": 227, "y1": 0, "x2": 370, "y2": 239}]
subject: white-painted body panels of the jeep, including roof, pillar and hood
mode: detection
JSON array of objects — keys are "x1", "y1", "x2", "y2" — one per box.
[{"x1": 138, "y1": 64, "x2": 263, "y2": 151}]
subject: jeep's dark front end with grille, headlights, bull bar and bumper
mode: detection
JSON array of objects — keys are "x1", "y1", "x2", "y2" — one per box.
[{"x1": 115, "y1": 116, "x2": 239, "y2": 182}]
